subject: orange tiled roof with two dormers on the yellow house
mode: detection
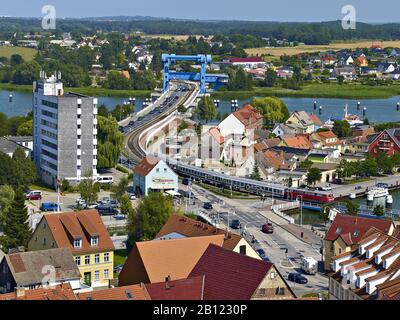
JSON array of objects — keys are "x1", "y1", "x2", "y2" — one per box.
[{"x1": 43, "y1": 210, "x2": 114, "y2": 254}]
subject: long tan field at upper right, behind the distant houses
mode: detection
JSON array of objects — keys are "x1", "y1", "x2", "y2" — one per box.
[{"x1": 246, "y1": 40, "x2": 400, "y2": 57}]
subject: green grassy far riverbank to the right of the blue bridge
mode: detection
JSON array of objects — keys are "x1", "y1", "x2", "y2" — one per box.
[{"x1": 212, "y1": 83, "x2": 400, "y2": 100}]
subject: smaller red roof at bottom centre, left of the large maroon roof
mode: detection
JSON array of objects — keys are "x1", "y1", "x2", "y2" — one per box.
[{"x1": 145, "y1": 276, "x2": 204, "y2": 300}]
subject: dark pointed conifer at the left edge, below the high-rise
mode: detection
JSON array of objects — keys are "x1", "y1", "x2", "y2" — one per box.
[{"x1": 1, "y1": 188, "x2": 32, "y2": 249}]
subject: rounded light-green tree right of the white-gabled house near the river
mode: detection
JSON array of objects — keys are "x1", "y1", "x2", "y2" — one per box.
[{"x1": 251, "y1": 97, "x2": 289, "y2": 126}]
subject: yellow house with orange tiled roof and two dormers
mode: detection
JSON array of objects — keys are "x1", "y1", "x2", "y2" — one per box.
[{"x1": 28, "y1": 210, "x2": 114, "y2": 287}]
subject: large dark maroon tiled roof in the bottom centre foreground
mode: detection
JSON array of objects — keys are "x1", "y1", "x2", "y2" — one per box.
[{"x1": 189, "y1": 244, "x2": 273, "y2": 300}]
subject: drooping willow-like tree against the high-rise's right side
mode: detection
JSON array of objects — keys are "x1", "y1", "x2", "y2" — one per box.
[{"x1": 97, "y1": 116, "x2": 124, "y2": 168}]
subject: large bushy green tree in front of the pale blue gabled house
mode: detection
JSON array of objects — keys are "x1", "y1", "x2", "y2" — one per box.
[{"x1": 127, "y1": 192, "x2": 174, "y2": 245}]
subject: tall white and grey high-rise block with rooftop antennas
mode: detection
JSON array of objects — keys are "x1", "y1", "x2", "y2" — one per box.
[{"x1": 33, "y1": 74, "x2": 97, "y2": 186}]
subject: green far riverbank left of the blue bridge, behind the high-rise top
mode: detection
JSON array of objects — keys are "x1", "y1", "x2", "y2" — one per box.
[{"x1": 0, "y1": 83, "x2": 152, "y2": 98}]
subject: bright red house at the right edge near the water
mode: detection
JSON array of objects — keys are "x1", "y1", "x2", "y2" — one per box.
[{"x1": 368, "y1": 128, "x2": 400, "y2": 157}]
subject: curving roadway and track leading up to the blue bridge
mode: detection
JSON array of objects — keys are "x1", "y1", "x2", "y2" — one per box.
[{"x1": 121, "y1": 82, "x2": 196, "y2": 166}]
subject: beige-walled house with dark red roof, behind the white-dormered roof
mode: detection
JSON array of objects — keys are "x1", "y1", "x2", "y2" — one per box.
[{"x1": 324, "y1": 214, "x2": 395, "y2": 271}]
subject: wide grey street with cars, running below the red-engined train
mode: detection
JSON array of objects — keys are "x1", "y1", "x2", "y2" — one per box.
[{"x1": 180, "y1": 185, "x2": 328, "y2": 296}]
